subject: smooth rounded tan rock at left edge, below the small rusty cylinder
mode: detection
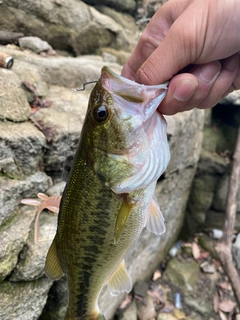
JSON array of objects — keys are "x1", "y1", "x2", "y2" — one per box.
[{"x1": 0, "y1": 68, "x2": 30, "y2": 122}]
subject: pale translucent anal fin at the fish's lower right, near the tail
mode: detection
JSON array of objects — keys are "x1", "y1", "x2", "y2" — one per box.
[{"x1": 108, "y1": 260, "x2": 132, "y2": 296}]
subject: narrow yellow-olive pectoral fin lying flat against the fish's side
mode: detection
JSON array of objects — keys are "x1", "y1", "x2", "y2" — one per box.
[{"x1": 114, "y1": 200, "x2": 133, "y2": 244}]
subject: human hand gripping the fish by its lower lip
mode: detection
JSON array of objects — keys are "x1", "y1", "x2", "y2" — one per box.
[{"x1": 122, "y1": 0, "x2": 240, "y2": 115}]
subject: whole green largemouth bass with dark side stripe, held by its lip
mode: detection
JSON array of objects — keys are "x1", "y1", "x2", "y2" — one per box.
[{"x1": 45, "y1": 67, "x2": 170, "y2": 320}]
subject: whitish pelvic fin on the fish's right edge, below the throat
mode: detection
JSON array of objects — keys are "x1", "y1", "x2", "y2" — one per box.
[{"x1": 146, "y1": 197, "x2": 166, "y2": 235}]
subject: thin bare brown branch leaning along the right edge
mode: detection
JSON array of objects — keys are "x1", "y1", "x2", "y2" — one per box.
[{"x1": 216, "y1": 127, "x2": 240, "y2": 307}]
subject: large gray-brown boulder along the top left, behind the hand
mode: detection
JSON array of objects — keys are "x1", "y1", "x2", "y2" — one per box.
[{"x1": 0, "y1": 0, "x2": 133, "y2": 55}]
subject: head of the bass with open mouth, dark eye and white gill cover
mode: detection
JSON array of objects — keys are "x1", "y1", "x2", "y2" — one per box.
[{"x1": 83, "y1": 67, "x2": 169, "y2": 193}]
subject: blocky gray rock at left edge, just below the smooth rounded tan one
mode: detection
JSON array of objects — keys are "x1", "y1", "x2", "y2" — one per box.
[{"x1": 0, "y1": 121, "x2": 46, "y2": 179}]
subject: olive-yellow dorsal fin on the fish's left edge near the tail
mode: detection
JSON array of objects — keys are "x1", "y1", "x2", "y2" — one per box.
[{"x1": 45, "y1": 239, "x2": 64, "y2": 280}]
